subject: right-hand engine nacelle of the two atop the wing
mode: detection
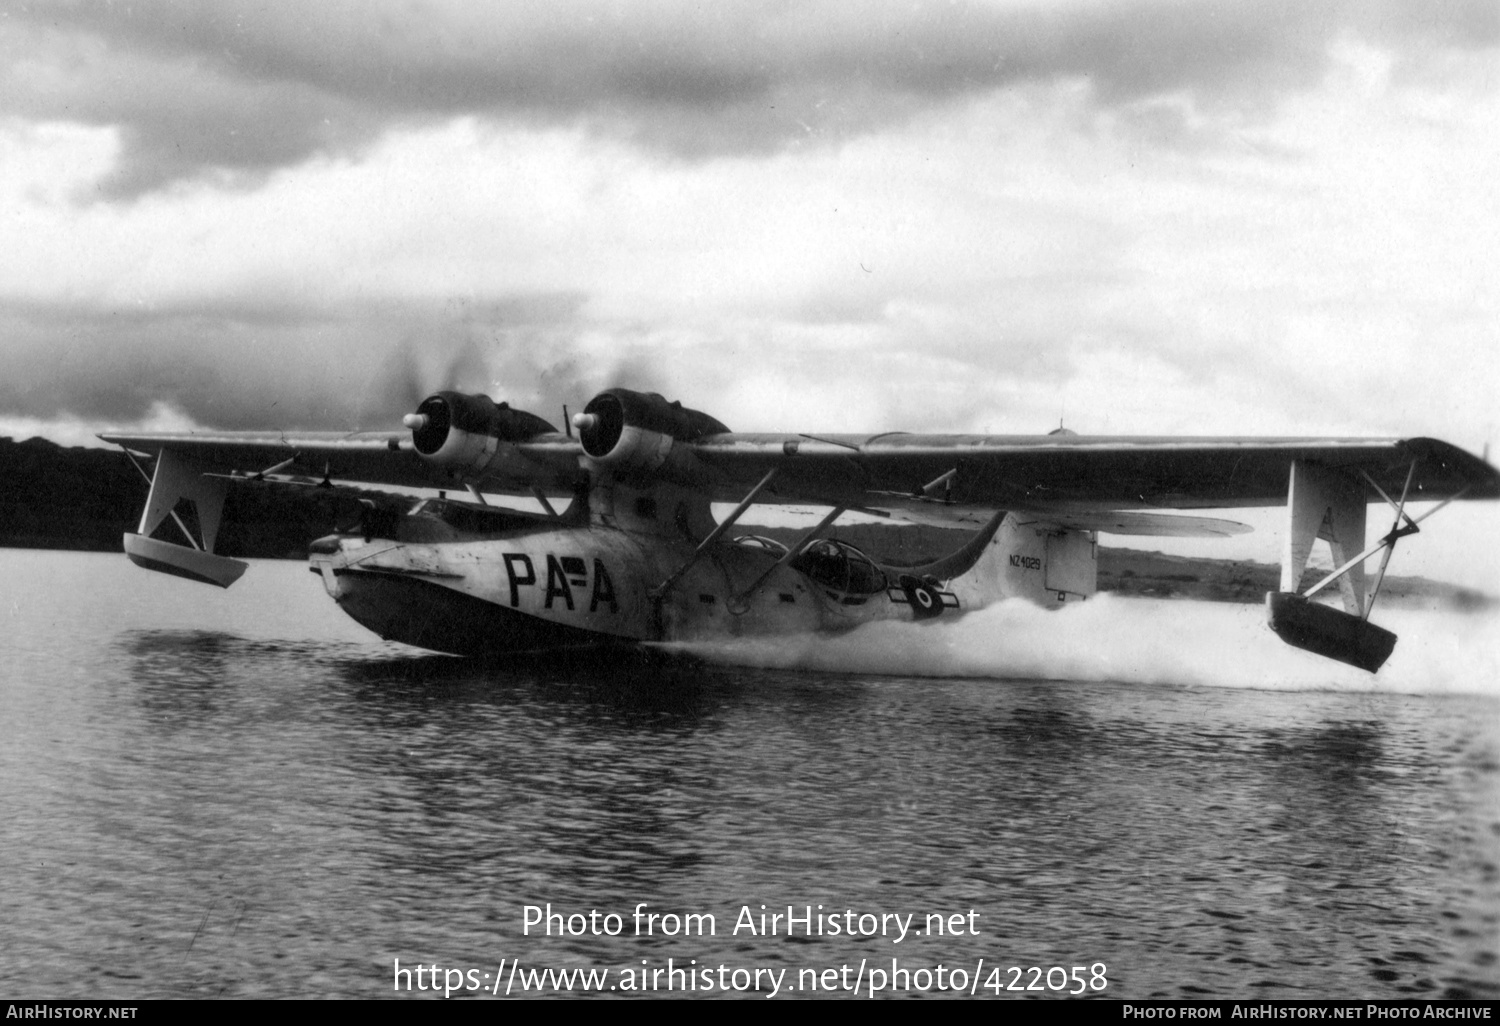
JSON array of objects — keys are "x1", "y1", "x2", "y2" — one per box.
[{"x1": 573, "y1": 389, "x2": 729, "y2": 477}]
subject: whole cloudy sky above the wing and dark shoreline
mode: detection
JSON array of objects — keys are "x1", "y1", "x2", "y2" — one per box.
[{"x1": 0, "y1": 0, "x2": 1500, "y2": 582}]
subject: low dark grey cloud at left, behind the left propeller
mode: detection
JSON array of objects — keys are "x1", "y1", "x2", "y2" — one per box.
[{"x1": 0, "y1": 288, "x2": 620, "y2": 431}]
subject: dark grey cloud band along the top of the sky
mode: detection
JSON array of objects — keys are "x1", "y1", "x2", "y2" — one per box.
[{"x1": 0, "y1": 0, "x2": 1500, "y2": 198}]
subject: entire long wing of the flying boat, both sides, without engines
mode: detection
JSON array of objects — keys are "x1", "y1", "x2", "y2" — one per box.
[{"x1": 101, "y1": 432, "x2": 1500, "y2": 516}]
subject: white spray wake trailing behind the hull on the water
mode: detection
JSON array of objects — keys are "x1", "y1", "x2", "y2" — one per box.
[{"x1": 675, "y1": 594, "x2": 1500, "y2": 696}]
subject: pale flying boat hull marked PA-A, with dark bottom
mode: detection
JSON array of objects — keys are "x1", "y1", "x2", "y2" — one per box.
[{"x1": 312, "y1": 507, "x2": 1094, "y2": 656}]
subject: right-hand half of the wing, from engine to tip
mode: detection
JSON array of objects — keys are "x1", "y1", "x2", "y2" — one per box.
[{"x1": 695, "y1": 435, "x2": 1500, "y2": 513}]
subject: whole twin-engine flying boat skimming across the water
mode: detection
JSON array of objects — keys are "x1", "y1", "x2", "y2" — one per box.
[{"x1": 101, "y1": 389, "x2": 1500, "y2": 672}]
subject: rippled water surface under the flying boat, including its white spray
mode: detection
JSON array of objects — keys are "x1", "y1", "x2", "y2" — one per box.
[{"x1": 0, "y1": 551, "x2": 1500, "y2": 998}]
